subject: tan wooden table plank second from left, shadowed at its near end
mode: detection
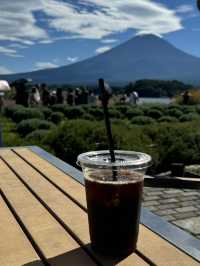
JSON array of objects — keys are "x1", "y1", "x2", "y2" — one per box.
[{"x1": 0, "y1": 157, "x2": 96, "y2": 266}]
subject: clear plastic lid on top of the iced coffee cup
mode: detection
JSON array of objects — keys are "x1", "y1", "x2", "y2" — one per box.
[{"x1": 77, "y1": 150, "x2": 152, "y2": 169}]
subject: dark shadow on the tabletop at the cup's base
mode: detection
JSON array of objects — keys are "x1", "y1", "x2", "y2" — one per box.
[{"x1": 22, "y1": 245, "x2": 131, "y2": 266}]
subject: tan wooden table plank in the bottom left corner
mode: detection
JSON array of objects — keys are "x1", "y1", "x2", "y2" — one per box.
[{"x1": 0, "y1": 195, "x2": 44, "y2": 266}]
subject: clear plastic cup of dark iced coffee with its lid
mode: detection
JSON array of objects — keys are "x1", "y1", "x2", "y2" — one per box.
[{"x1": 78, "y1": 151, "x2": 151, "y2": 256}]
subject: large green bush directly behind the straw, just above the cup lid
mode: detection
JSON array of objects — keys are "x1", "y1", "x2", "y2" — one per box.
[{"x1": 45, "y1": 120, "x2": 150, "y2": 165}]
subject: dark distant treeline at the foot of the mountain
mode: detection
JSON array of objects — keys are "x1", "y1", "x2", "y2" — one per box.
[{"x1": 49, "y1": 79, "x2": 194, "y2": 97}]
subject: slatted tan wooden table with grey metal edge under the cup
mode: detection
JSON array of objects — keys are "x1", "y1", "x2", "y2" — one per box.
[{"x1": 0, "y1": 147, "x2": 200, "y2": 266}]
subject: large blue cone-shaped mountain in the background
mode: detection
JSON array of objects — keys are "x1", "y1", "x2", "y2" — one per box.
[{"x1": 0, "y1": 35, "x2": 200, "y2": 84}]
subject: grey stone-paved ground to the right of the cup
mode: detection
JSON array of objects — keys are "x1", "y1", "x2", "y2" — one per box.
[{"x1": 143, "y1": 187, "x2": 200, "y2": 239}]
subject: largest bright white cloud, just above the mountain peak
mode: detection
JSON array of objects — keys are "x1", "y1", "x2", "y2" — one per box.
[{"x1": 46, "y1": 0, "x2": 182, "y2": 39}]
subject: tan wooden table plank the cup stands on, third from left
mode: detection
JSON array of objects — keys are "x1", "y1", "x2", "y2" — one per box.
[{"x1": 0, "y1": 150, "x2": 149, "y2": 266}]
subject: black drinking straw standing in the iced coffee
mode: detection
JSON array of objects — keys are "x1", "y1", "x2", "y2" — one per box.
[{"x1": 99, "y1": 79, "x2": 117, "y2": 181}]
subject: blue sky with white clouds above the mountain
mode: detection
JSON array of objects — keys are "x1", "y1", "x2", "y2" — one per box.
[{"x1": 0, "y1": 0, "x2": 200, "y2": 74}]
